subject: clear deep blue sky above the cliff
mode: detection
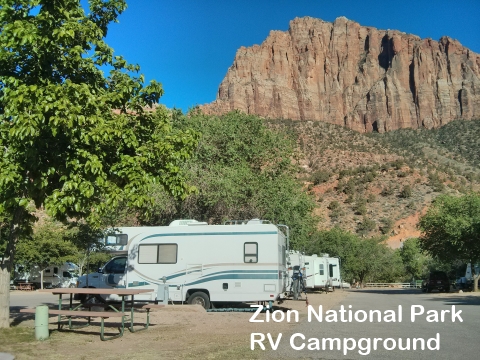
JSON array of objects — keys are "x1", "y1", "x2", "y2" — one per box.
[{"x1": 98, "y1": 0, "x2": 480, "y2": 111}]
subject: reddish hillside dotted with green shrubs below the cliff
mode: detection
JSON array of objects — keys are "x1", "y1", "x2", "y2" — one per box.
[{"x1": 269, "y1": 120, "x2": 480, "y2": 248}]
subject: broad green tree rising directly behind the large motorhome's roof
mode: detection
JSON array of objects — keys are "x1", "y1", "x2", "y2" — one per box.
[{"x1": 142, "y1": 110, "x2": 318, "y2": 249}]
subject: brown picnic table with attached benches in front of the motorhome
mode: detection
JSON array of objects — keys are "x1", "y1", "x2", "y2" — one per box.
[{"x1": 20, "y1": 288, "x2": 156, "y2": 340}]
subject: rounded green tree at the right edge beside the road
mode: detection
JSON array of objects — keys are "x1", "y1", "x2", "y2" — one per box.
[{"x1": 419, "y1": 193, "x2": 480, "y2": 290}]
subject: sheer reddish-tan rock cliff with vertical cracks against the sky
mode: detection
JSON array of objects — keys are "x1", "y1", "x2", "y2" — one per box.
[{"x1": 201, "y1": 17, "x2": 480, "y2": 132}]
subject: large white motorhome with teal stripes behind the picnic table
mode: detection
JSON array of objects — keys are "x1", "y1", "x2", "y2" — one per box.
[{"x1": 78, "y1": 219, "x2": 288, "y2": 308}]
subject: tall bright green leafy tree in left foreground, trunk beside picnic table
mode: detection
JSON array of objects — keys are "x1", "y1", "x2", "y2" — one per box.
[{"x1": 0, "y1": 0, "x2": 196, "y2": 328}]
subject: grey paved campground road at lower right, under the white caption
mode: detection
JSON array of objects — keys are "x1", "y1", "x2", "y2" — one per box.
[{"x1": 262, "y1": 289, "x2": 480, "y2": 360}]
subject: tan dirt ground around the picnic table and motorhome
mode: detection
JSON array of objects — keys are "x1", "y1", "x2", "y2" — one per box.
[{"x1": 0, "y1": 290, "x2": 348, "y2": 360}]
